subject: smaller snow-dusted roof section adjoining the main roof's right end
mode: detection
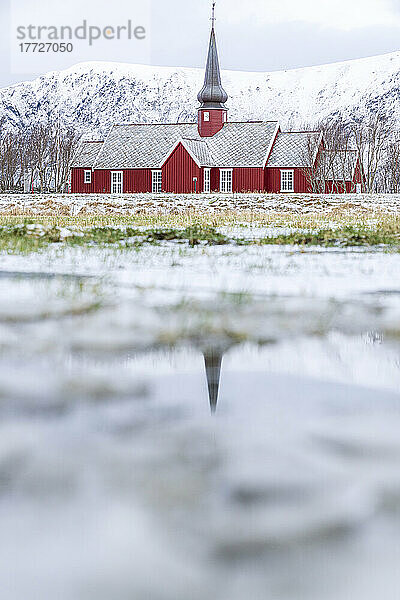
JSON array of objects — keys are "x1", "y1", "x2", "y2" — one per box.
[{"x1": 267, "y1": 131, "x2": 320, "y2": 168}]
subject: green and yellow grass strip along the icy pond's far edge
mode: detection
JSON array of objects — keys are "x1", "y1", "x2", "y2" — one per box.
[{"x1": 0, "y1": 219, "x2": 400, "y2": 254}]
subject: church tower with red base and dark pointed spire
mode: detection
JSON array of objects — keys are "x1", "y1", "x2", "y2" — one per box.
[{"x1": 197, "y1": 2, "x2": 228, "y2": 137}]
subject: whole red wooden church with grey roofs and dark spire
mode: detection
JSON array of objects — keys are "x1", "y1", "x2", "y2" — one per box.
[{"x1": 71, "y1": 7, "x2": 361, "y2": 194}]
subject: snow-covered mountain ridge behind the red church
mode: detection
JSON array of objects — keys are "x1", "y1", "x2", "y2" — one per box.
[{"x1": 0, "y1": 52, "x2": 400, "y2": 137}]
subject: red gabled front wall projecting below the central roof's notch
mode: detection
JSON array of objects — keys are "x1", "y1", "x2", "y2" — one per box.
[{"x1": 162, "y1": 144, "x2": 203, "y2": 194}]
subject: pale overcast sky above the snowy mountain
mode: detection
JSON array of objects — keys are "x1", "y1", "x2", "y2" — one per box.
[{"x1": 0, "y1": 0, "x2": 400, "y2": 86}]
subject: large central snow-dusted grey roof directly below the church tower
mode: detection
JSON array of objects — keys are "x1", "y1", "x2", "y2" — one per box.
[{"x1": 73, "y1": 121, "x2": 279, "y2": 169}]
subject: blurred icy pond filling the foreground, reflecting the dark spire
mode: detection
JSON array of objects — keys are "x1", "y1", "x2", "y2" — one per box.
[{"x1": 0, "y1": 236, "x2": 400, "y2": 600}]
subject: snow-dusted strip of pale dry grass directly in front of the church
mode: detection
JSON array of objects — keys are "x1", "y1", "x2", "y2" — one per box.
[{"x1": 0, "y1": 194, "x2": 400, "y2": 215}]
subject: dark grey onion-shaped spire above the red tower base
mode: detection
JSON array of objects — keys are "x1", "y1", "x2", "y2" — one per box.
[{"x1": 197, "y1": 2, "x2": 228, "y2": 108}]
